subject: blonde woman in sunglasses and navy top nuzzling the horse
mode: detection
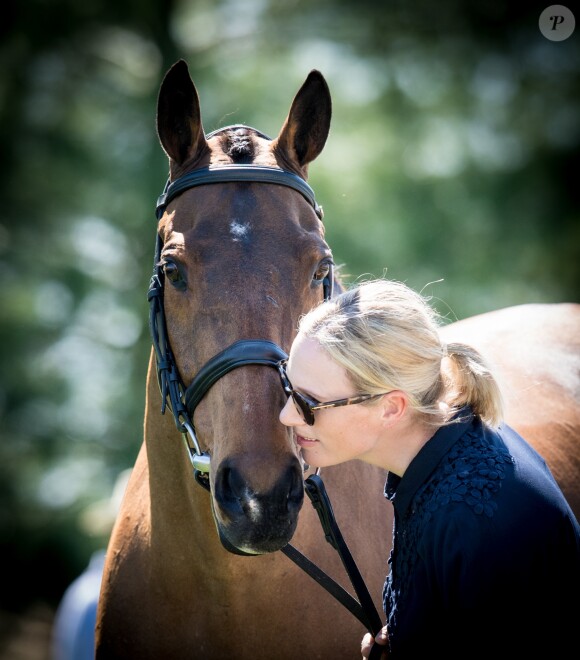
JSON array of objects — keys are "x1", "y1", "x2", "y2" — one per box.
[{"x1": 280, "y1": 280, "x2": 580, "y2": 660}]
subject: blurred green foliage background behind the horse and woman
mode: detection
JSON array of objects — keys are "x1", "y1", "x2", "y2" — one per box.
[{"x1": 0, "y1": 0, "x2": 580, "y2": 651}]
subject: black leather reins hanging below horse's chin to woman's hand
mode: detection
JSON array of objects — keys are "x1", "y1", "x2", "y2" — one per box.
[{"x1": 281, "y1": 474, "x2": 386, "y2": 660}]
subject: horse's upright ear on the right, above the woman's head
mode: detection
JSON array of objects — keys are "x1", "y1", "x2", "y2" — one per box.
[{"x1": 273, "y1": 69, "x2": 332, "y2": 175}]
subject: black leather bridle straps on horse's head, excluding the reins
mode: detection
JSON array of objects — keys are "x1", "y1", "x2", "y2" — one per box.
[{"x1": 147, "y1": 125, "x2": 333, "y2": 480}]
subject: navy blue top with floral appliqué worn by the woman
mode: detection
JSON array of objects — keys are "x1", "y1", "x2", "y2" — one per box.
[{"x1": 383, "y1": 408, "x2": 580, "y2": 660}]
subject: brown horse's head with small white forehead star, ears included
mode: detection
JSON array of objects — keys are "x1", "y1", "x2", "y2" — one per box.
[{"x1": 156, "y1": 61, "x2": 332, "y2": 554}]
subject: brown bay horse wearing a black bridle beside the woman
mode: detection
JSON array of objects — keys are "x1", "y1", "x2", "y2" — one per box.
[{"x1": 96, "y1": 60, "x2": 580, "y2": 660}]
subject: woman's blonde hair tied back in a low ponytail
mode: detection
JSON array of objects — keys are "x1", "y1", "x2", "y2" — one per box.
[{"x1": 298, "y1": 279, "x2": 503, "y2": 427}]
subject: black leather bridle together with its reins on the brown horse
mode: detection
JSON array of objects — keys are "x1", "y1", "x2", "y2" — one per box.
[{"x1": 147, "y1": 126, "x2": 383, "y2": 658}]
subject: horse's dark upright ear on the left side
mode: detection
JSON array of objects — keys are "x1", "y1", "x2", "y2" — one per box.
[{"x1": 157, "y1": 60, "x2": 208, "y2": 165}]
